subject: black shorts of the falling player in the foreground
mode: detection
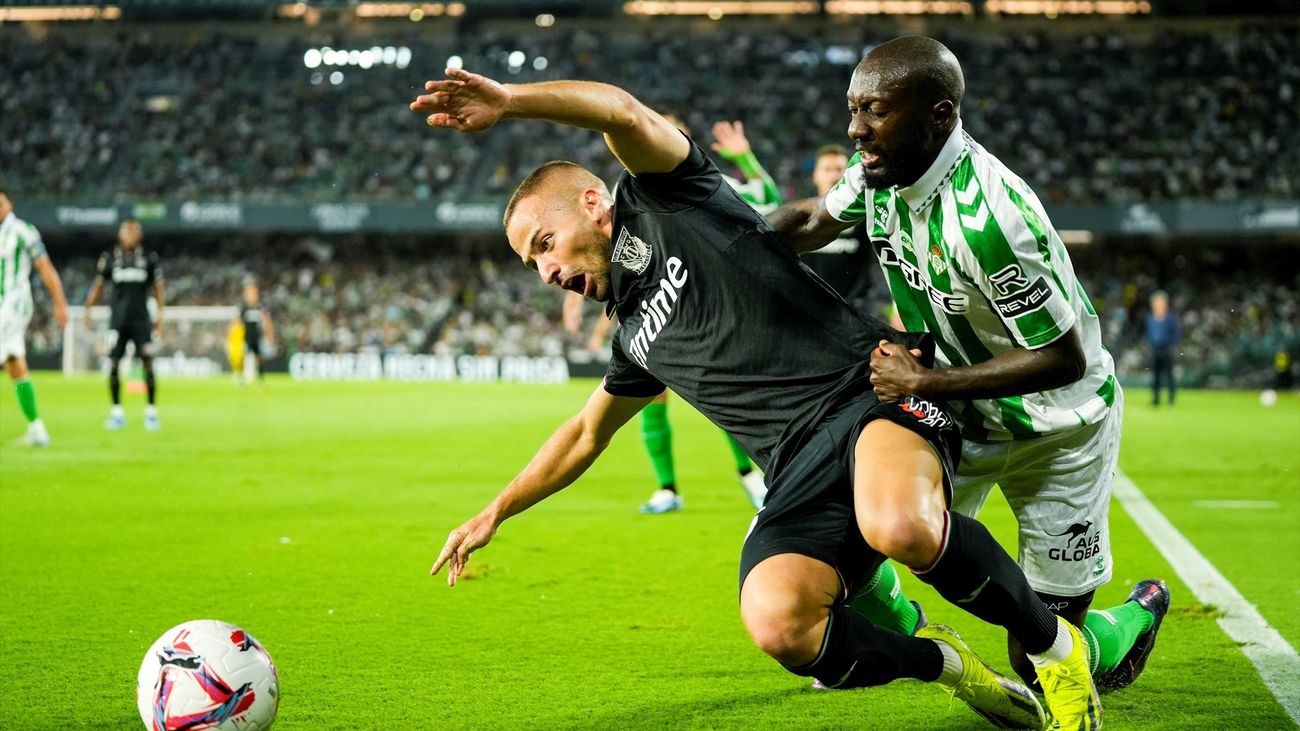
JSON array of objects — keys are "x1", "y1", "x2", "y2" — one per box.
[{"x1": 740, "y1": 395, "x2": 962, "y2": 596}]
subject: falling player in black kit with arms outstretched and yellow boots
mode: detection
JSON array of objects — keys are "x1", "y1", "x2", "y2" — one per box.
[{"x1": 411, "y1": 69, "x2": 1091, "y2": 728}]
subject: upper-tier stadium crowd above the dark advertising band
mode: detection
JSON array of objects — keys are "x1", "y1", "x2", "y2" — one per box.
[{"x1": 0, "y1": 23, "x2": 1300, "y2": 204}]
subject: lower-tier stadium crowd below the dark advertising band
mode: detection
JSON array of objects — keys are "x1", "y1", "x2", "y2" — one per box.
[{"x1": 29, "y1": 239, "x2": 1300, "y2": 386}]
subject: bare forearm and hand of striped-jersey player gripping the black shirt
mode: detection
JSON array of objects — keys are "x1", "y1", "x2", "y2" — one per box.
[{"x1": 872, "y1": 330, "x2": 1087, "y2": 399}]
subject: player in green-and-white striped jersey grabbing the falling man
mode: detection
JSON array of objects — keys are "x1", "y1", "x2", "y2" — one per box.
[{"x1": 772, "y1": 36, "x2": 1169, "y2": 702}]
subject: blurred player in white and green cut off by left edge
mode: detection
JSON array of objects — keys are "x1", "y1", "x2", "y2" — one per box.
[{"x1": 0, "y1": 190, "x2": 68, "y2": 446}]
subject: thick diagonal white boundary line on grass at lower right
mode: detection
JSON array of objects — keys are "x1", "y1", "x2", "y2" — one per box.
[{"x1": 1114, "y1": 472, "x2": 1300, "y2": 727}]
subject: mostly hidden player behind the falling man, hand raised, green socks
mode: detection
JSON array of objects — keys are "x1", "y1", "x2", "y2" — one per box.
[{"x1": 564, "y1": 113, "x2": 769, "y2": 515}]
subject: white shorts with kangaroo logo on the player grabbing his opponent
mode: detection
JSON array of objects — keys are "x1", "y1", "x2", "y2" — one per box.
[{"x1": 953, "y1": 388, "x2": 1125, "y2": 597}]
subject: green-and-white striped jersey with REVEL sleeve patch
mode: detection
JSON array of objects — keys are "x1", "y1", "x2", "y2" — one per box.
[{"x1": 826, "y1": 122, "x2": 1119, "y2": 441}]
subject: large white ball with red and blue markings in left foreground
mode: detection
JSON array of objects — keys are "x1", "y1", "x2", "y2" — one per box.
[{"x1": 135, "y1": 619, "x2": 280, "y2": 731}]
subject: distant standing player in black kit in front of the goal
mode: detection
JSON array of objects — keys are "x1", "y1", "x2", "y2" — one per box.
[{"x1": 86, "y1": 219, "x2": 163, "y2": 432}]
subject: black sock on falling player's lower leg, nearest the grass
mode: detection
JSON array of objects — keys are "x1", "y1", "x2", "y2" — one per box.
[{"x1": 785, "y1": 604, "x2": 944, "y2": 688}]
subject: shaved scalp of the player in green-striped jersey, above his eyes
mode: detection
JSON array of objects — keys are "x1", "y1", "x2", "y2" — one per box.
[{"x1": 854, "y1": 35, "x2": 966, "y2": 108}]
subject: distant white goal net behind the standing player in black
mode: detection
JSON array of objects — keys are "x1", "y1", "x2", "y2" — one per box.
[{"x1": 64, "y1": 300, "x2": 238, "y2": 379}]
